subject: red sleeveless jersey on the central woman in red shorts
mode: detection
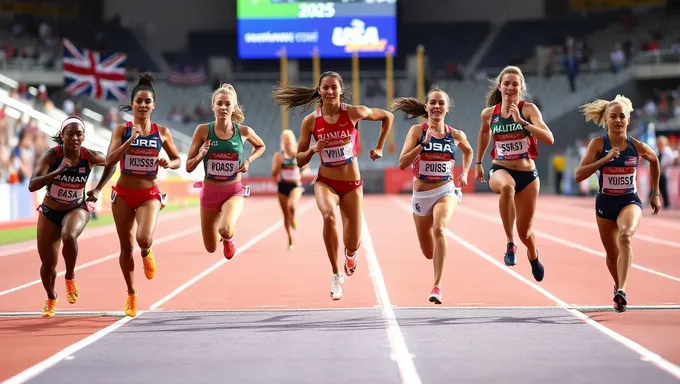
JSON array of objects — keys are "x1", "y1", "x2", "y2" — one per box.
[{"x1": 313, "y1": 103, "x2": 358, "y2": 167}]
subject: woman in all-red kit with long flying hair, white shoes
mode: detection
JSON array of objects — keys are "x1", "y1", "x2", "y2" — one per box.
[{"x1": 273, "y1": 72, "x2": 394, "y2": 300}]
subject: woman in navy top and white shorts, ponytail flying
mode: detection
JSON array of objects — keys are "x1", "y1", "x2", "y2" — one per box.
[{"x1": 391, "y1": 87, "x2": 472, "y2": 304}]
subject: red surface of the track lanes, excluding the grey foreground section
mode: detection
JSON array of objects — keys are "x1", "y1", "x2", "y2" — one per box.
[{"x1": 0, "y1": 195, "x2": 680, "y2": 380}]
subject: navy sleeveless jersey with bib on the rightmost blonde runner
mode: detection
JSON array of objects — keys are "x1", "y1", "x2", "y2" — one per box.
[{"x1": 596, "y1": 134, "x2": 639, "y2": 196}]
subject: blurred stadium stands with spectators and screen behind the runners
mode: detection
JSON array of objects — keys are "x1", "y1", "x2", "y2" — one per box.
[{"x1": 0, "y1": 0, "x2": 680, "y2": 225}]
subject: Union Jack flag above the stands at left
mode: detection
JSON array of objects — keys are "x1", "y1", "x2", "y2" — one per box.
[{"x1": 63, "y1": 39, "x2": 127, "y2": 100}]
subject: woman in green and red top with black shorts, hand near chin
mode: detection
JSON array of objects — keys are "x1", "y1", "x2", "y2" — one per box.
[{"x1": 475, "y1": 66, "x2": 554, "y2": 281}]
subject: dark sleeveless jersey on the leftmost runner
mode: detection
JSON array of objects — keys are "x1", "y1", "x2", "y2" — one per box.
[{"x1": 46, "y1": 145, "x2": 91, "y2": 205}]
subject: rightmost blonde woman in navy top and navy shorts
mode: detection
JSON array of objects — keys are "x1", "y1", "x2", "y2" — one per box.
[{"x1": 575, "y1": 95, "x2": 661, "y2": 312}]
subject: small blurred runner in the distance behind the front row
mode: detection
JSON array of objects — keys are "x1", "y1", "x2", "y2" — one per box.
[{"x1": 272, "y1": 129, "x2": 309, "y2": 249}]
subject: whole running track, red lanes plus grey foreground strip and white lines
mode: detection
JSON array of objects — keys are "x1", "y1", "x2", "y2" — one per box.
[{"x1": 0, "y1": 194, "x2": 680, "y2": 384}]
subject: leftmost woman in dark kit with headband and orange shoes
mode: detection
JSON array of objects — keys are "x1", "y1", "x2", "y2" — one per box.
[{"x1": 28, "y1": 116, "x2": 116, "y2": 317}]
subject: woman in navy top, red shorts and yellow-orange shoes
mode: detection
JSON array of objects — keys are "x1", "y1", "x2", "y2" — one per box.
[{"x1": 106, "y1": 72, "x2": 181, "y2": 316}]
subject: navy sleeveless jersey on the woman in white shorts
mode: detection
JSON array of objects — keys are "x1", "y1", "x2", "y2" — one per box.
[{"x1": 413, "y1": 123, "x2": 456, "y2": 182}]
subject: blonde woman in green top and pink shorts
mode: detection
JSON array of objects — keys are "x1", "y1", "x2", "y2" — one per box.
[{"x1": 186, "y1": 84, "x2": 265, "y2": 259}]
